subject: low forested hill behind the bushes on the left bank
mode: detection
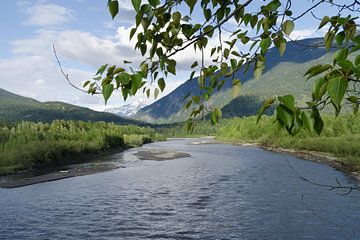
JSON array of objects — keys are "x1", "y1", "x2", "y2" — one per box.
[{"x1": 0, "y1": 88, "x2": 140, "y2": 124}]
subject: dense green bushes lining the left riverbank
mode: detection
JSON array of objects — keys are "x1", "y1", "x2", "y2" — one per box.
[{"x1": 0, "y1": 120, "x2": 165, "y2": 175}]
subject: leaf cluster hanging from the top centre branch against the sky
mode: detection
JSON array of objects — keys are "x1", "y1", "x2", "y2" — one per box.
[{"x1": 100, "y1": 0, "x2": 294, "y2": 123}]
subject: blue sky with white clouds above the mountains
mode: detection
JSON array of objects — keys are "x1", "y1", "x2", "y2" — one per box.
[{"x1": 0, "y1": 0, "x2": 346, "y2": 110}]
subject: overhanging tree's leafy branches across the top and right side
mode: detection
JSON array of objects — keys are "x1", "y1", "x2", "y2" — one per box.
[{"x1": 84, "y1": 0, "x2": 360, "y2": 135}]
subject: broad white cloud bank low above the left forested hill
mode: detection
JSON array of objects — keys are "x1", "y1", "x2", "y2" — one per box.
[{"x1": 0, "y1": 25, "x2": 182, "y2": 109}]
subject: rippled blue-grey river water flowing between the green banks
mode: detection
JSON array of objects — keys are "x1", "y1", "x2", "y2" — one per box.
[{"x1": 0, "y1": 139, "x2": 360, "y2": 239}]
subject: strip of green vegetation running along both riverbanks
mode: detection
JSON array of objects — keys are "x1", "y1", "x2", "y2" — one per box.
[{"x1": 0, "y1": 115, "x2": 360, "y2": 187}]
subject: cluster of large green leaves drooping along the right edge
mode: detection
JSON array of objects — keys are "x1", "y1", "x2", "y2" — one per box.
[{"x1": 258, "y1": 16, "x2": 360, "y2": 135}]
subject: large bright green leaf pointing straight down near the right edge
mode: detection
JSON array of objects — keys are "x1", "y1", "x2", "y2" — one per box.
[{"x1": 327, "y1": 77, "x2": 348, "y2": 114}]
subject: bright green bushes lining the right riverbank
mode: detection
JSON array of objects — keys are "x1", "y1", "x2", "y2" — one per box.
[{"x1": 216, "y1": 115, "x2": 360, "y2": 172}]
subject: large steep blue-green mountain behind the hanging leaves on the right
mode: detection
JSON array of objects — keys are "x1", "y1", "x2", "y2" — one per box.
[{"x1": 135, "y1": 38, "x2": 331, "y2": 123}]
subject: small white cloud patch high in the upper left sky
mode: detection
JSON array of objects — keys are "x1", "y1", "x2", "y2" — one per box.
[{"x1": 20, "y1": 2, "x2": 73, "y2": 27}]
